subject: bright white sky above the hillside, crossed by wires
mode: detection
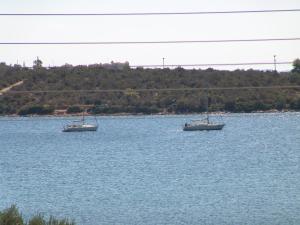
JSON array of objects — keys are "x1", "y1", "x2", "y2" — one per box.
[{"x1": 0, "y1": 0, "x2": 300, "y2": 71}]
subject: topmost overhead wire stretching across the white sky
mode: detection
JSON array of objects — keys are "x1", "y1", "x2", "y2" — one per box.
[{"x1": 0, "y1": 9, "x2": 300, "y2": 16}]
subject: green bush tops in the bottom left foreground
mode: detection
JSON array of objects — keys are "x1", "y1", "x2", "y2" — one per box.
[{"x1": 0, "y1": 205, "x2": 75, "y2": 225}]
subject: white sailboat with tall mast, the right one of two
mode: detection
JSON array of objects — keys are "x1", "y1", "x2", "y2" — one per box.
[{"x1": 183, "y1": 90, "x2": 225, "y2": 131}]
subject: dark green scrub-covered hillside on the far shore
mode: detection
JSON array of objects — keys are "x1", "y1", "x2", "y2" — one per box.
[{"x1": 0, "y1": 59, "x2": 300, "y2": 115}]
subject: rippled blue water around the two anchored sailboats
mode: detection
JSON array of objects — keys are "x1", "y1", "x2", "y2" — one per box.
[{"x1": 0, "y1": 113, "x2": 300, "y2": 225}]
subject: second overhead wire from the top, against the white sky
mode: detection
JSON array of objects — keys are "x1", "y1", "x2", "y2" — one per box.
[{"x1": 0, "y1": 37, "x2": 300, "y2": 45}]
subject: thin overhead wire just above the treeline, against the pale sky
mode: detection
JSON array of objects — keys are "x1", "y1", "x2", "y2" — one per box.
[{"x1": 130, "y1": 62, "x2": 293, "y2": 68}]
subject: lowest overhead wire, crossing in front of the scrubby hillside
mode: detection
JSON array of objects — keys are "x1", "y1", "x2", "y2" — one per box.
[{"x1": 3, "y1": 85, "x2": 300, "y2": 94}]
